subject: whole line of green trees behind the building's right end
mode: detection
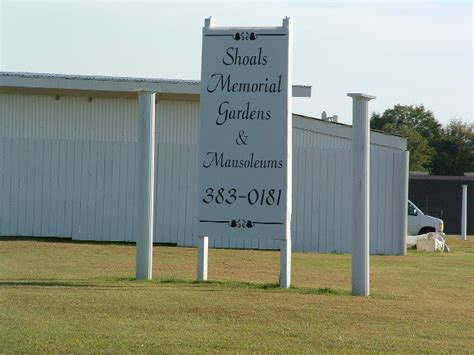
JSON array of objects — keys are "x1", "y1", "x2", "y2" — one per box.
[{"x1": 370, "y1": 105, "x2": 474, "y2": 176}]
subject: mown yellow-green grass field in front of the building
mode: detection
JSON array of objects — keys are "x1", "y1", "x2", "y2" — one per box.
[{"x1": 0, "y1": 237, "x2": 474, "y2": 353}]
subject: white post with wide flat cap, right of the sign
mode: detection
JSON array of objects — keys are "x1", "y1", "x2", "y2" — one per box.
[{"x1": 347, "y1": 93, "x2": 375, "y2": 296}]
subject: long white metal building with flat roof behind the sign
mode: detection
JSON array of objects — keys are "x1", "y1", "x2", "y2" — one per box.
[{"x1": 0, "y1": 73, "x2": 408, "y2": 254}]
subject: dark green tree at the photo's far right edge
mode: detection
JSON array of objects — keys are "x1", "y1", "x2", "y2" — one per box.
[{"x1": 432, "y1": 119, "x2": 474, "y2": 176}]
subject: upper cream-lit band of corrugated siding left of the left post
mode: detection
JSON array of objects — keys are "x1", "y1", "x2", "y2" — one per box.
[{"x1": 0, "y1": 94, "x2": 137, "y2": 142}]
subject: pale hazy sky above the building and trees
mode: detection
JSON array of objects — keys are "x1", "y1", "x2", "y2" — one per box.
[{"x1": 0, "y1": 0, "x2": 474, "y2": 125}]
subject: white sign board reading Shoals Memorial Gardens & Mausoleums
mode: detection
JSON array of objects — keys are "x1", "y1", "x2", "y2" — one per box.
[{"x1": 197, "y1": 19, "x2": 292, "y2": 239}]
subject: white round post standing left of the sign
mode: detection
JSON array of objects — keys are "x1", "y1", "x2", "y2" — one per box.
[{"x1": 136, "y1": 92, "x2": 155, "y2": 280}]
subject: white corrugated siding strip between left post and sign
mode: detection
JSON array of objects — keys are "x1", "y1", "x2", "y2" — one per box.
[{"x1": 154, "y1": 100, "x2": 199, "y2": 245}]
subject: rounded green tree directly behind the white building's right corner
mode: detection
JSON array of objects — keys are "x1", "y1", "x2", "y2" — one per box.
[{"x1": 370, "y1": 105, "x2": 442, "y2": 172}]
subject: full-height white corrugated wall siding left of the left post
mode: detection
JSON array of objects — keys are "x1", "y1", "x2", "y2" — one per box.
[{"x1": 0, "y1": 94, "x2": 137, "y2": 241}]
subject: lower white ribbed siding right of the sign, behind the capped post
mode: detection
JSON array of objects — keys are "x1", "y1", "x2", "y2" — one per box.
[{"x1": 292, "y1": 145, "x2": 405, "y2": 254}]
